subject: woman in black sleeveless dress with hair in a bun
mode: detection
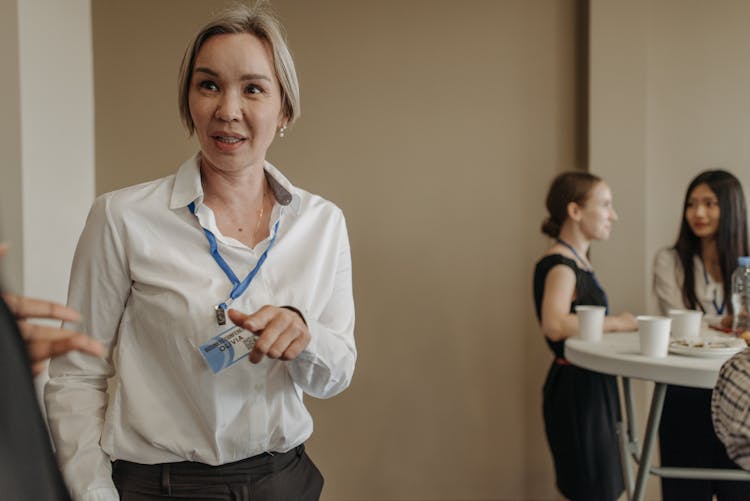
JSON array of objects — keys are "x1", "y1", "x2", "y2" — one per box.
[{"x1": 534, "y1": 172, "x2": 637, "y2": 501}]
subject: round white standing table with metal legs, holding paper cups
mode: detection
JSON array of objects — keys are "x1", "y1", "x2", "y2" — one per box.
[{"x1": 565, "y1": 331, "x2": 750, "y2": 501}]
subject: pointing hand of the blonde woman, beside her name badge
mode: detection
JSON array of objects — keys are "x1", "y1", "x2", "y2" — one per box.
[{"x1": 228, "y1": 305, "x2": 310, "y2": 364}]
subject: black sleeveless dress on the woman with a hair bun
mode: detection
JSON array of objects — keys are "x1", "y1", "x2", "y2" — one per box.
[{"x1": 534, "y1": 254, "x2": 624, "y2": 501}]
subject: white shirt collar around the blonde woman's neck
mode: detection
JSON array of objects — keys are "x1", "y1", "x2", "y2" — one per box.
[{"x1": 169, "y1": 152, "x2": 300, "y2": 212}]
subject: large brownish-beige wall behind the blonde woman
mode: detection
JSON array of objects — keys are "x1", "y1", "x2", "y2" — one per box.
[{"x1": 92, "y1": 0, "x2": 581, "y2": 500}]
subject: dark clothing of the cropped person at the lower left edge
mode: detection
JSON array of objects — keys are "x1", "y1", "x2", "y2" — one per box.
[{"x1": 0, "y1": 299, "x2": 70, "y2": 501}]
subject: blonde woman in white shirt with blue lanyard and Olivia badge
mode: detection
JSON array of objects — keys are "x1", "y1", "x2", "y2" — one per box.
[{"x1": 46, "y1": 5, "x2": 356, "y2": 501}]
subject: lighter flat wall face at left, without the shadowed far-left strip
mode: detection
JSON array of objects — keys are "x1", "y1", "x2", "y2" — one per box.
[{"x1": 18, "y1": 0, "x2": 94, "y2": 303}]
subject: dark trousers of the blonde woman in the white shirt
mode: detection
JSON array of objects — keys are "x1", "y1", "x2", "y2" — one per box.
[{"x1": 112, "y1": 445, "x2": 323, "y2": 501}]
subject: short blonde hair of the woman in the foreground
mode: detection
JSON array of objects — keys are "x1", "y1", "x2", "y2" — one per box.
[{"x1": 178, "y1": 0, "x2": 302, "y2": 135}]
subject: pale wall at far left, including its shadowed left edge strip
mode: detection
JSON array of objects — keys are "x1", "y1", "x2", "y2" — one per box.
[{"x1": 0, "y1": 0, "x2": 94, "y2": 302}]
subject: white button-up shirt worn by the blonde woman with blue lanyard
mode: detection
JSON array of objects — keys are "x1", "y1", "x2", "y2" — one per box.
[{"x1": 46, "y1": 156, "x2": 356, "y2": 500}]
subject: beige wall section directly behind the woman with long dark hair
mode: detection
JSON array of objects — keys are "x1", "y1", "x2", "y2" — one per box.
[{"x1": 645, "y1": 0, "x2": 750, "y2": 288}]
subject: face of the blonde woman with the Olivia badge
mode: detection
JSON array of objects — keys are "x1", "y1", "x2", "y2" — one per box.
[{"x1": 188, "y1": 33, "x2": 286, "y2": 172}]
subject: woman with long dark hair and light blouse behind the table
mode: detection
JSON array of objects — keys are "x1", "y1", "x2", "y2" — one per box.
[{"x1": 653, "y1": 170, "x2": 750, "y2": 501}]
